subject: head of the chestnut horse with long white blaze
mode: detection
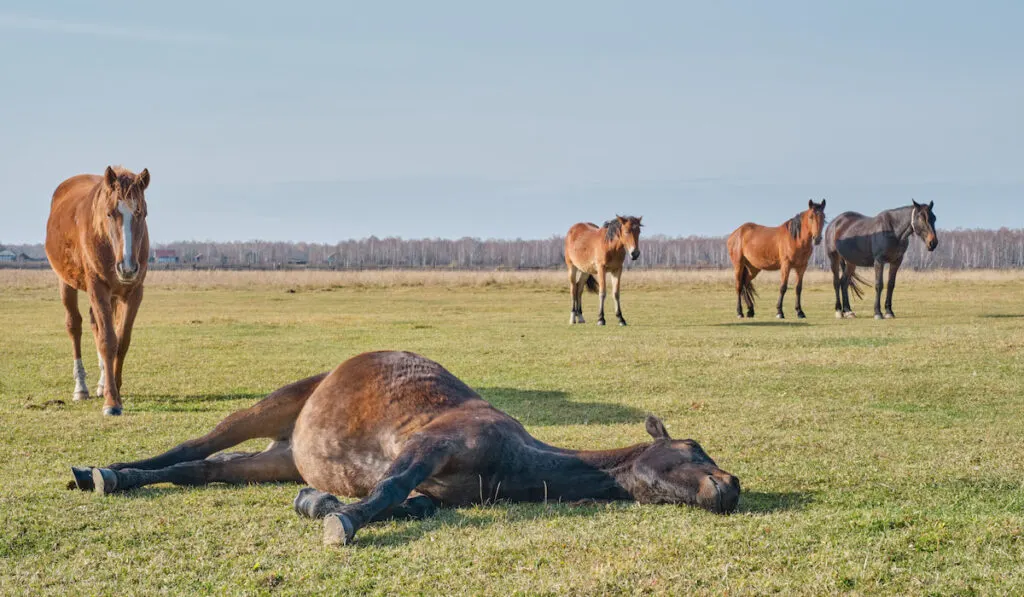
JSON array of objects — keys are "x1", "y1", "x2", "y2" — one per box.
[{"x1": 96, "y1": 166, "x2": 150, "y2": 283}]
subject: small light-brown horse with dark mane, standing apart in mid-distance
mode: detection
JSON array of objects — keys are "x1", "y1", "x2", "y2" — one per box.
[{"x1": 565, "y1": 215, "x2": 643, "y2": 326}]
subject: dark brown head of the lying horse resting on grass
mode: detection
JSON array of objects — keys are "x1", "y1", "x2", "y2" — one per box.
[{"x1": 631, "y1": 415, "x2": 739, "y2": 514}]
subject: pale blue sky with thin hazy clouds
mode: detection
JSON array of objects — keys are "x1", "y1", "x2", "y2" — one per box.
[{"x1": 0, "y1": 0, "x2": 1024, "y2": 244}]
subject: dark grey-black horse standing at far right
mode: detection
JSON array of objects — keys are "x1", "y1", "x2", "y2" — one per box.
[{"x1": 825, "y1": 200, "x2": 939, "y2": 319}]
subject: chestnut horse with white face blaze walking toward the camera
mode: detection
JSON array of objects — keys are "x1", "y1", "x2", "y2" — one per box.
[{"x1": 46, "y1": 166, "x2": 150, "y2": 416}]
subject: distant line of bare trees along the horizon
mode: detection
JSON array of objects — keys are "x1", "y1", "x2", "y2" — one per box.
[{"x1": 0, "y1": 228, "x2": 1024, "y2": 269}]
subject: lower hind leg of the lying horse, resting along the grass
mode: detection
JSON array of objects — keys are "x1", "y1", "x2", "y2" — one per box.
[{"x1": 92, "y1": 441, "x2": 302, "y2": 494}]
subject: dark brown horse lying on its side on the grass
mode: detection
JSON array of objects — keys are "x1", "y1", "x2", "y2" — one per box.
[{"x1": 73, "y1": 352, "x2": 739, "y2": 543}]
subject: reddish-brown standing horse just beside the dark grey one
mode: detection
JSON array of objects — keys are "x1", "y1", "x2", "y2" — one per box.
[{"x1": 727, "y1": 199, "x2": 825, "y2": 319}]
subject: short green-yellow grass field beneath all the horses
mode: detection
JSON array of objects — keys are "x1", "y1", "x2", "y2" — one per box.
[{"x1": 0, "y1": 271, "x2": 1024, "y2": 595}]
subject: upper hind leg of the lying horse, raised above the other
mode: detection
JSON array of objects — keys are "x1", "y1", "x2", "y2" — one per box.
[{"x1": 69, "y1": 373, "x2": 327, "y2": 492}]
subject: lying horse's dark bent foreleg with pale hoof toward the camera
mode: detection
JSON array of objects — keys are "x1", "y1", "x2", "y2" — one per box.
[{"x1": 315, "y1": 431, "x2": 456, "y2": 545}]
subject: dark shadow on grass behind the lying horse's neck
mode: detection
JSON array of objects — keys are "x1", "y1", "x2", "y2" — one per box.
[{"x1": 477, "y1": 387, "x2": 647, "y2": 426}]
